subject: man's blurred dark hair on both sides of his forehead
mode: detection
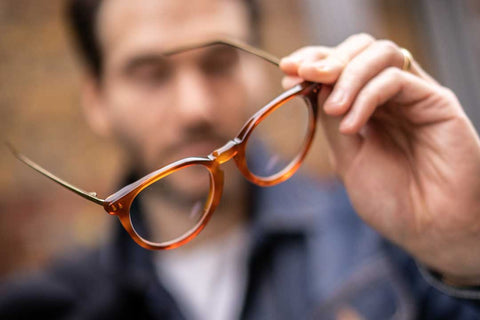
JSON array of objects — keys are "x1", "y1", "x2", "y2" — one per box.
[{"x1": 67, "y1": 0, "x2": 260, "y2": 78}]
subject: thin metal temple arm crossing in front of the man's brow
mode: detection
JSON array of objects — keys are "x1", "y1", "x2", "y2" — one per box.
[{"x1": 163, "y1": 38, "x2": 280, "y2": 67}]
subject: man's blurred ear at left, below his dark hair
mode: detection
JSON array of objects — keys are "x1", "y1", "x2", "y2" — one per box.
[{"x1": 81, "y1": 74, "x2": 112, "y2": 137}]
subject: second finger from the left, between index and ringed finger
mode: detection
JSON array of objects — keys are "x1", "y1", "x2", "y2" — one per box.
[{"x1": 298, "y1": 34, "x2": 374, "y2": 84}]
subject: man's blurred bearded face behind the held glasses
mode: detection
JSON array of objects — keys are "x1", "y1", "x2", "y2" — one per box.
[{"x1": 98, "y1": 0, "x2": 256, "y2": 173}]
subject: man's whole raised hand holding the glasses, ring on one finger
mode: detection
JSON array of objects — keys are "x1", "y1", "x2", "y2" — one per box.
[{"x1": 280, "y1": 34, "x2": 480, "y2": 285}]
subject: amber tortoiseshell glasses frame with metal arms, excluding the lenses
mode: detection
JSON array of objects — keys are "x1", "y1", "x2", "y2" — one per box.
[{"x1": 9, "y1": 39, "x2": 321, "y2": 250}]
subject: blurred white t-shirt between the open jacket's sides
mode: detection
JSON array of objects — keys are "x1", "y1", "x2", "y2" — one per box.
[{"x1": 155, "y1": 226, "x2": 248, "y2": 320}]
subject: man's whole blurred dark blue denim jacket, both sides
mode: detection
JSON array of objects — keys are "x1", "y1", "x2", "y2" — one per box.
[{"x1": 0, "y1": 174, "x2": 480, "y2": 319}]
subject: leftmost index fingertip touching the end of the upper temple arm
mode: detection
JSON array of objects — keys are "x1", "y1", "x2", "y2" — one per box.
[{"x1": 280, "y1": 46, "x2": 333, "y2": 76}]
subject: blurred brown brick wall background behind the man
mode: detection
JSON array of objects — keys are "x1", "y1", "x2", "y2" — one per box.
[{"x1": 0, "y1": 0, "x2": 480, "y2": 277}]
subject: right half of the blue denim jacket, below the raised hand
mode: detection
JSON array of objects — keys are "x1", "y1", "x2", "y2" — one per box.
[{"x1": 237, "y1": 177, "x2": 480, "y2": 319}]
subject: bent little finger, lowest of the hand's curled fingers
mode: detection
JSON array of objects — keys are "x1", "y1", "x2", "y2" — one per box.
[{"x1": 340, "y1": 67, "x2": 433, "y2": 134}]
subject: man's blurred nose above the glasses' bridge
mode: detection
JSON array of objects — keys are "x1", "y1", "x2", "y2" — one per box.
[{"x1": 175, "y1": 70, "x2": 215, "y2": 125}]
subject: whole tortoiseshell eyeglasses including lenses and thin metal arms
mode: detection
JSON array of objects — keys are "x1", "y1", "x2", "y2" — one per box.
[{"x1": 9, "y1": 39, "x2": 321, "y2": 250}]
